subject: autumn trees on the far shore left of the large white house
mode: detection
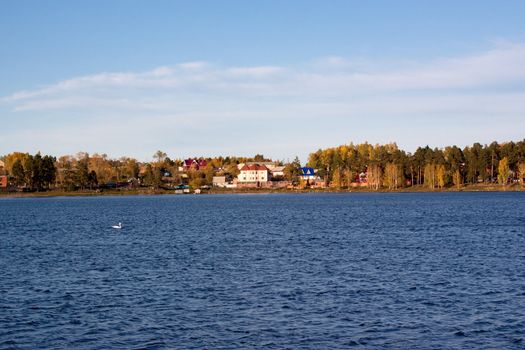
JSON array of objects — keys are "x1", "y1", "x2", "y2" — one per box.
[{"x1": 0, "y1": 151, "x2": 271, "y2": 191}]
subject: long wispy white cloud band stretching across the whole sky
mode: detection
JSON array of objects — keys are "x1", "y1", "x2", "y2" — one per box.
[{"x1": 0, "y1": 43, "x2": 525, "y2": 159}]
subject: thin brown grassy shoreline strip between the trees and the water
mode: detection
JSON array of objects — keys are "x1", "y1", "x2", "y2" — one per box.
[{"x1": 0, "y1": 184, "x2": 525, "y2": 198}]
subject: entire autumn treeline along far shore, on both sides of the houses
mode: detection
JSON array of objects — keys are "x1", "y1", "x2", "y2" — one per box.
[{"x1": 0, "y1": 140, "x2": 525, "y2": 191}]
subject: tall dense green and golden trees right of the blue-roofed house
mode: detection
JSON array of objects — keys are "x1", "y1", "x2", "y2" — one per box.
[{"x1": 308, "y1": 140, "x2": 525, "y2": 189}]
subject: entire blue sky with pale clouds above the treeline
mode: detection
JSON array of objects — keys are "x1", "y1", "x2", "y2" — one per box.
[{"x1": 0, "y1": 0, "x2": 525, "y2": 161}]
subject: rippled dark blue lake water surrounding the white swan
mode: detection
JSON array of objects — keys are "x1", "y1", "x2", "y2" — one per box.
[{"x1": 0, "y1": 193, "x2": 525, "y2": 349}]
